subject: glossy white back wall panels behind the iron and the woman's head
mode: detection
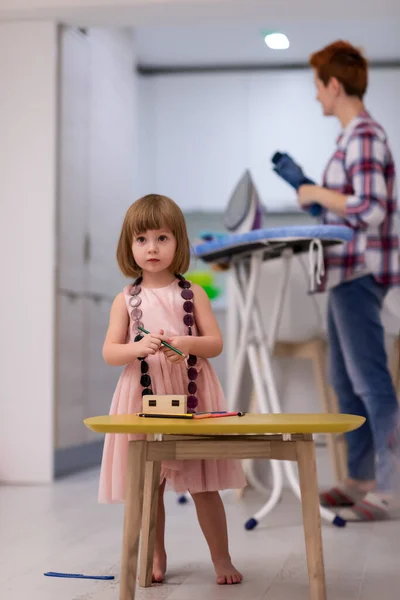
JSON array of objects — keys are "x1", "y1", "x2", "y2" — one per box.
[{"x1": 140, "y1": 69, "x2": 400, "y2": 211}]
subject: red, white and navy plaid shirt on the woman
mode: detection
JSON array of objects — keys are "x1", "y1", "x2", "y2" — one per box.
[{"x1": 320, "y1": 112, "x2": 400, "y2": 291}]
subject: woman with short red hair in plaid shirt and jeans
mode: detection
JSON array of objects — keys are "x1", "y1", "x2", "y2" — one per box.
[{"x1": 298, "y1": 41, "x2": 400, "y2": 521}]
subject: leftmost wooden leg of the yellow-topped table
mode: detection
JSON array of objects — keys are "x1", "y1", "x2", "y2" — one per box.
[{"x1": 119, "y1": 441, "x2": 146, "y2": 600}]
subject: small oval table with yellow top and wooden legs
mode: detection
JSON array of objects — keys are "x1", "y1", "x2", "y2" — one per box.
[{"x1": 84, "y1": 414, "x2": 365, "y2": 600}]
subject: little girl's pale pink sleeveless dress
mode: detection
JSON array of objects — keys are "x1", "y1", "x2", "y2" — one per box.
[{"x1": 99, "y1": 280, "x2": 246, "y2": 503}]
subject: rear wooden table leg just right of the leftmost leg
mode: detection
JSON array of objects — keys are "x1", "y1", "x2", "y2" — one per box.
[{"x1": 139, "y1": 461, "x2": 161, "y2": 587}]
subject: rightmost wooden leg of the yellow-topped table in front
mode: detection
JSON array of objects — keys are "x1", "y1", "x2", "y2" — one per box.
[{"x1": 296, "y1": 441, "x2": 326, "y2": 600}]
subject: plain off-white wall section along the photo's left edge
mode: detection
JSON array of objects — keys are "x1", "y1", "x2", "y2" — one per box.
[{"x1": 0, "y1": 23, "x2": 57, "y2": 482}]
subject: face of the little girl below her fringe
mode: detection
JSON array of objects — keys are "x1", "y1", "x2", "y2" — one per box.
[{"x1": 132, "y1": 229, "x2": 176, "y2": 273}]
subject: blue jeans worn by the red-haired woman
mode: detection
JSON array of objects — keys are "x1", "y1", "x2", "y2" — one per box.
[{"x1": 328, "y1": 275, "x2": 399, "y2": 492}]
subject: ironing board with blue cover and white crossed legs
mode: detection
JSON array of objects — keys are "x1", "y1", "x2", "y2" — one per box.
[{"x1": 194, "y1": 225, "x2": 353, "y2": 530}]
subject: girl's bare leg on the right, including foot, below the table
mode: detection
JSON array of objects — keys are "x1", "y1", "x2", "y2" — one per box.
[{"x1": 192, "y1": 492, "x2": 243, "y2": 585}]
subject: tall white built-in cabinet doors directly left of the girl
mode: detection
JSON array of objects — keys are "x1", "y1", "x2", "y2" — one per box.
[{"x1": 56, "y1": 27, "x2": 137, "y2": 450}]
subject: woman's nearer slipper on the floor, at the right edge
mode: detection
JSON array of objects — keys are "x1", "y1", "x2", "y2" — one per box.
[{"x1": 339, "y1": 492, "x2": 400, "y2": 522}]
